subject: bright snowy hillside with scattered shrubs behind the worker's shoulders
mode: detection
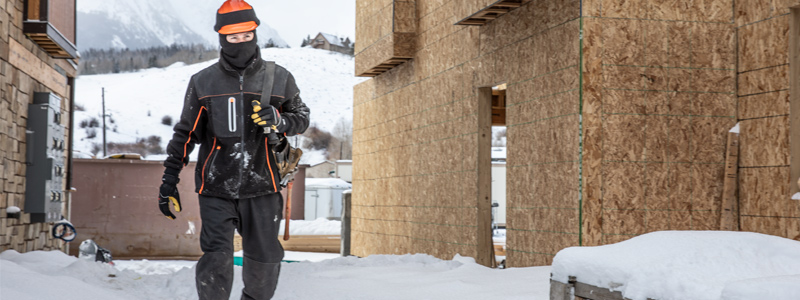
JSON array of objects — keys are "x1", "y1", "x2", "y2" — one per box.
[{"x1": 75, "y1": 48, "x2": 364, "y2": 163}]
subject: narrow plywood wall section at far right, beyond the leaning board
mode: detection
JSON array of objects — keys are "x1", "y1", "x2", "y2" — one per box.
[{"x1": 735, "y1": 0, "x2": 800, "y2": 240}]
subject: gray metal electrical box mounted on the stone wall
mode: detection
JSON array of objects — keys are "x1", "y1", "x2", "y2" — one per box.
[{"x1": 24, "y1": 93, "x2": 66, "y2": 223}]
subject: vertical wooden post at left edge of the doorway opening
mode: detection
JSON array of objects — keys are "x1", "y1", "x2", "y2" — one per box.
[{"x1": 475, "y1": 87, "x2": 494, "y2": 267}]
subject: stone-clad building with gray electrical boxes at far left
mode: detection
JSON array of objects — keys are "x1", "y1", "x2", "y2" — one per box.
[{"x1": 0, "y1": 0, "x2": 78, "y2": 252}]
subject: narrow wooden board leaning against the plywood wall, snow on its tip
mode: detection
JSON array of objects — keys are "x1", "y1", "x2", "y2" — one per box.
[{"x1": 719, "y1": 132, "x2": 739, "y2": 231}]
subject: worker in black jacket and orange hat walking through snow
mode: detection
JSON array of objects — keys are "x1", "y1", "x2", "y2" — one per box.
[{"x1": 158, "y1": 0, "x2": 309, "y2": 300}]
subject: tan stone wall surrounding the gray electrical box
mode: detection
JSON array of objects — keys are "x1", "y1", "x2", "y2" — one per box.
[{"x1": 0, "y1": 0, "x2": 76, "y2": 252}]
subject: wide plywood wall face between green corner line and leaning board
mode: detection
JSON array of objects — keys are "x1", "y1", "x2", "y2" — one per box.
[{"x1": 582, "y1": 0, "x2": 736, "y2": 246}]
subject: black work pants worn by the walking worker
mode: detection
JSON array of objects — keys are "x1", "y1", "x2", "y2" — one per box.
[{"x1": 195, "y1": 193, "x2": 283, "y2": 300}]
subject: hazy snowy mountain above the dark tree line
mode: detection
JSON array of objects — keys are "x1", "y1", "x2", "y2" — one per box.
[{"x1": 77, "y1": 0, "x2": 287, "y2": 50}]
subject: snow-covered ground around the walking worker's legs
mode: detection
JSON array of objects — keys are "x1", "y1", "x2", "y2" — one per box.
[{"x1": 0, "y1": 250, "x2": 550, "y2": 300}]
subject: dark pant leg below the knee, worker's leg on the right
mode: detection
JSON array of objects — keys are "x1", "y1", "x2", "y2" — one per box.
[{"x1": 241, "y1": 257, "x2": 281, "y2": 300}]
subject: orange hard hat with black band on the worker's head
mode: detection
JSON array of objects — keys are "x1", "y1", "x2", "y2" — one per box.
[{"x1": 214, "y1": 0, "x2": 261, "y2": 34}]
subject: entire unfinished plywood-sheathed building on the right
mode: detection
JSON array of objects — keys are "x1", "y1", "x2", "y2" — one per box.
[{"x1": 352, "y1": 0, "x2": 800, "y2": 267}]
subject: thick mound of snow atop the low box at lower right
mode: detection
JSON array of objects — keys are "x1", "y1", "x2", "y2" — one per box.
[{"x1": 552, "y1": 231, "x2": 800, "y2": 300}]
